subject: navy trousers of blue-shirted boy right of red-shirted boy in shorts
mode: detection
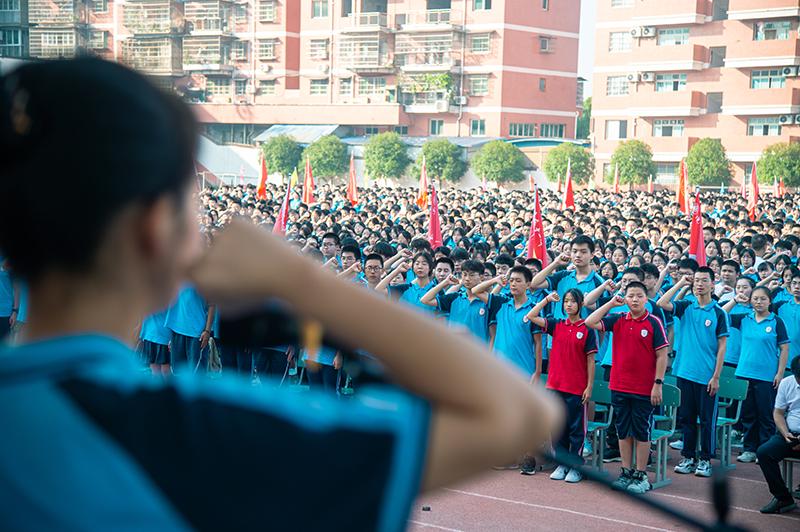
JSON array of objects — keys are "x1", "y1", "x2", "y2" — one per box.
[{"x1": 678, "y1": 377, "x2": 719, "y2": 460}]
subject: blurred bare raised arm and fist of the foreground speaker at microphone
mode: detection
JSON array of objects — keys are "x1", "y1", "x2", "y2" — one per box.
[{"x1": 190, "y1": 221, "x2": 563, "y2": 490}]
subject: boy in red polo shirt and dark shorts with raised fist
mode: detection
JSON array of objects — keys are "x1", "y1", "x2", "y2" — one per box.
[{"x1": 586, "y1": 281, "x2": 669, "y2": 493}]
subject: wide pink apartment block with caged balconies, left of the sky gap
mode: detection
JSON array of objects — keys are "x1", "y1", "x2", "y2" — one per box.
[{"x1": 0, "y1": 0, "x2": 580, "y2": 142}]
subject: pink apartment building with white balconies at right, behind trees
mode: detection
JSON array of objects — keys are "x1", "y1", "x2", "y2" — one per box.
[{"x1": 592, "y1": 0, "x2": 800, "y2": 184}]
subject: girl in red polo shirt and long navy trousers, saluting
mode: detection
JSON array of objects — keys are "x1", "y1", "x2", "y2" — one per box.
[{"x1": 528, "y1": 288, "x2": 597, "y2": 483}]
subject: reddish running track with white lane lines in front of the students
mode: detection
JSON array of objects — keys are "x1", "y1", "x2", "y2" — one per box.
[{"x1": 409, "y1": 451, "x2": 800, "y2": 532}]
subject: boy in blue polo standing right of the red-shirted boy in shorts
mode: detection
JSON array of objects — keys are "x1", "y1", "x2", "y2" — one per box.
[{"x1": 658, "y1": 266, "x2": 728, "y2": 477}]
